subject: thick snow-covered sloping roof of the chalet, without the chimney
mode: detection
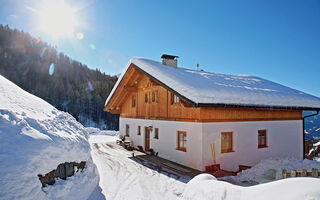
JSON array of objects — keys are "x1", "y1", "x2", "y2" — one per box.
[{"x1": 106, "y1": 57, "x2": 320, "y2": 110}]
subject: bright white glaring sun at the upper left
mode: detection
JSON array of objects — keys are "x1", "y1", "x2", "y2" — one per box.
[{"x1": 39, "y1": 0, "x2": 78, "y2": 37}]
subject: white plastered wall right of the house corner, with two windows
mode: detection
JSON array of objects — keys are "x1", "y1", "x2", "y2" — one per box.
[{"x1": 202, "y1": 120, "x2": 303, "y2": 171}]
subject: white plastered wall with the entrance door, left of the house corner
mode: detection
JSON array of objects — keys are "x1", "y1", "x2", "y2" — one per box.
[{"x1": 119, "y1": 117, "x2": 202, "y2": 169}]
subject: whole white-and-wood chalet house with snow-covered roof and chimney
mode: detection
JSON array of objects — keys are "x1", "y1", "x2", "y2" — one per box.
[{"x1": 105, "y1": 55, "x2": 320, "y2": 171}]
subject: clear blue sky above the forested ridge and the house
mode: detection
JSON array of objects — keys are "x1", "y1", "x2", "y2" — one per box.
[{"x1": 0, "y1": 0, "x2": 320, "y2": 96}]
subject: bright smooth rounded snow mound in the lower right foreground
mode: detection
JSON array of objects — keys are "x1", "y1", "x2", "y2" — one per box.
[{"x1": 182, "y1": 174, "x2": 320, "y2": 200}]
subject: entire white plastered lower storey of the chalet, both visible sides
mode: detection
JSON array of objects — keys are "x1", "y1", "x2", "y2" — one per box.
[{"x1": 120, "y1": 117, "x2": 303, "y2": 171}]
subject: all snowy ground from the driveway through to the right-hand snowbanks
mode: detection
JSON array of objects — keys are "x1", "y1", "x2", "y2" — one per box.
[{"x1": 89, "y1": 135, "x2": 320, "y2": 200}]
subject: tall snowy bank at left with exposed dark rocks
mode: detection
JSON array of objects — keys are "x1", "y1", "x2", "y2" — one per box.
[{"x1": 0, "y1": 75, "x2": 99, "y2": 199}]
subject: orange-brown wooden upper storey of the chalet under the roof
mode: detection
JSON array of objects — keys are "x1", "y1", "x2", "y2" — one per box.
[{"x1": 105, "y1": 64, "x2": 302, "y2": 122}]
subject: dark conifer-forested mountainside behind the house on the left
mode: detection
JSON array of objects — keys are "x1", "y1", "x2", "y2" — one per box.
[{"x1": 0, "y1": 25, "x2": 119, "y2": 129}]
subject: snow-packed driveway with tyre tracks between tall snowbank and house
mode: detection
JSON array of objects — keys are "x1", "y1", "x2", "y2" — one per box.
[{"x1": 89, "y1": 135, "x2": 186, "y2": 200}]
